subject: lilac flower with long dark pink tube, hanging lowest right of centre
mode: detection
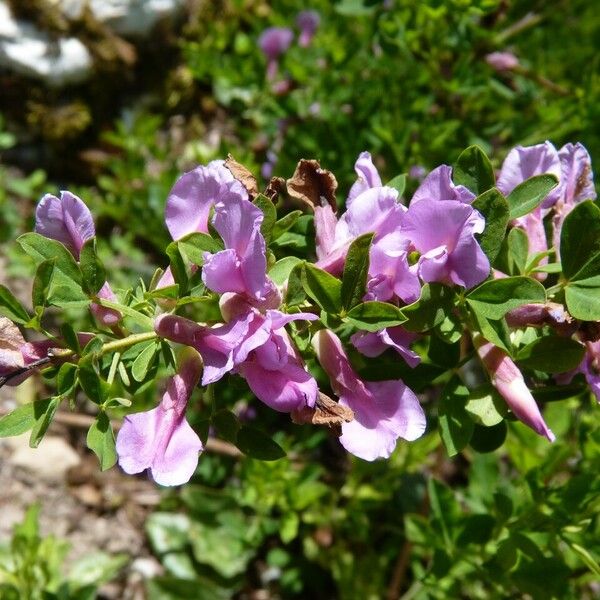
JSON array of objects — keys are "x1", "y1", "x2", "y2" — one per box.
[{"x1": 312, "y1": 329, "x2": 425, "y2": 461}]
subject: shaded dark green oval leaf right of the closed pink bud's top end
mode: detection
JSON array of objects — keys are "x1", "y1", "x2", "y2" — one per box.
[{"x1": 516, "y1": 336, "x2": 585, "y2": 373}]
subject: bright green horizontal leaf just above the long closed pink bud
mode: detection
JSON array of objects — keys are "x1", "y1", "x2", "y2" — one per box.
[{"x1": 467, "y1": 277, "x2": 546, "y2": 322}]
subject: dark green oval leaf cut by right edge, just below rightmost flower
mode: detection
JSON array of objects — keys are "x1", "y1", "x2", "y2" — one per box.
[{"x1": 560, "y1": 200, "x2": 600, "y2": 281}]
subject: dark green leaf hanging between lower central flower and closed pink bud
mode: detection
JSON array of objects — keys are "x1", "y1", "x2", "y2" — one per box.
[{"x1": 438, "y1": 376, "x2": 474, "y2": 456}]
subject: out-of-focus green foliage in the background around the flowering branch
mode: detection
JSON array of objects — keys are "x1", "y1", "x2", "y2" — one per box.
[{"x1": 0, "y1": 0, "x2": 600, "y2": 600}]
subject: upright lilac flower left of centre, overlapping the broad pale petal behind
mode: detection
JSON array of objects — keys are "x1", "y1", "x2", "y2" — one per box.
[{"x1": 202, "y1": 195, "x2": 278, "y2": 304}]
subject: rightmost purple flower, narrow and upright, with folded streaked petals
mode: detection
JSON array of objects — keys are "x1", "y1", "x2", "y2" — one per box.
[{"x1": 552, "y1": 143, "x2": 596, "y2": 258}]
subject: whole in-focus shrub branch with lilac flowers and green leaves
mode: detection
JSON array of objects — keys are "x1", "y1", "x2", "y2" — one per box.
[{"x1": 0, "y1": 142, "x2": 600, "y2": 485}]
